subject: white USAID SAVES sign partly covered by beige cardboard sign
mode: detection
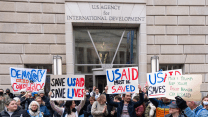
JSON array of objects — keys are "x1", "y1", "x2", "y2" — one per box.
[{"x1": 147, "y1": 69, "x2": 182, "y2": 98}]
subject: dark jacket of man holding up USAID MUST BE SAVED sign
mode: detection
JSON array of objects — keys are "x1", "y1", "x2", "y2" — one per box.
[{"x1": 106, "y1": 93, "x2": 144, "y2": 117}]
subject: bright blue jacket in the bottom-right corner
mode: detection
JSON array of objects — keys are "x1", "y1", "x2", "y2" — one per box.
[{"x1": 184, "y1": 105, "x2": 208, "y2": 117}]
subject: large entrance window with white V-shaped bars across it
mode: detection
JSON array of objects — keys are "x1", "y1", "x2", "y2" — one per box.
[{"x1": 74, "y1": 27, "x2": 138, "y2": 74}]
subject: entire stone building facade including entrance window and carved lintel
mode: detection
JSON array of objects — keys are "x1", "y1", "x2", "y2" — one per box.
[{"x1": 0, "y1": 0, "x2": 208, "y2": 96}]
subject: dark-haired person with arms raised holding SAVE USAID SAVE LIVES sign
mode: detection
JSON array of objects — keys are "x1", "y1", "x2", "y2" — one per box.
[{"x1": 48, "y1": 92, "x2": 86, "y2": 117}]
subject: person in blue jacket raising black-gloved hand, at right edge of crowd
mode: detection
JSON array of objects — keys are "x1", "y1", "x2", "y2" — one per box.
[{"x1": 176, "y1": 96, "x2": 208, "y2": 117}]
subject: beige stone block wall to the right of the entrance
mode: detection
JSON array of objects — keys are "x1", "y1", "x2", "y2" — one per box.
[{"x1": 147, "y1": 0, "x2": 208, "y2": 96}]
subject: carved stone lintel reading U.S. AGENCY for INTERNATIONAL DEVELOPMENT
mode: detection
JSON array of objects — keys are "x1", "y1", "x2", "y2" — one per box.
[{"x1": 65, "y1": 2, "x2": 146, "y2": 23}]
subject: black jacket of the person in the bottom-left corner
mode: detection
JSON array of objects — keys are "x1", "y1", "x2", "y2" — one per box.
[{"x1": 0, "y1": 107, "x2": 30, "y2": 117}]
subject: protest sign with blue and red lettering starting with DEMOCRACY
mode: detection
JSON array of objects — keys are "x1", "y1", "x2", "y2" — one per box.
[{"x1": 10, "y1": 67, "x2": 47, "y2": 92}]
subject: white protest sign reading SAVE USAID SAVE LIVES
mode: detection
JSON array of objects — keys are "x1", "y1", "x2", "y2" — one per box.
[{"x1": 50, "y1": 75, "x2": 85, "y2": 100}]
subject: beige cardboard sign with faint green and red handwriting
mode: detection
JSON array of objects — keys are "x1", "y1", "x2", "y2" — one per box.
[{"x1": 166, "y1": 75, "x2": 202, "y2": 101}]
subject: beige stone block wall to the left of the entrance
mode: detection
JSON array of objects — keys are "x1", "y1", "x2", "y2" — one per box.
[{"x1": 0, "y1": 0, "x2": 66, "y2": 89}]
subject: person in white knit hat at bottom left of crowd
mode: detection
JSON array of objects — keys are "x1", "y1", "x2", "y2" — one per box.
[{"x1": 27, "y1": 101, "x2": 43, "y2": 117}]
